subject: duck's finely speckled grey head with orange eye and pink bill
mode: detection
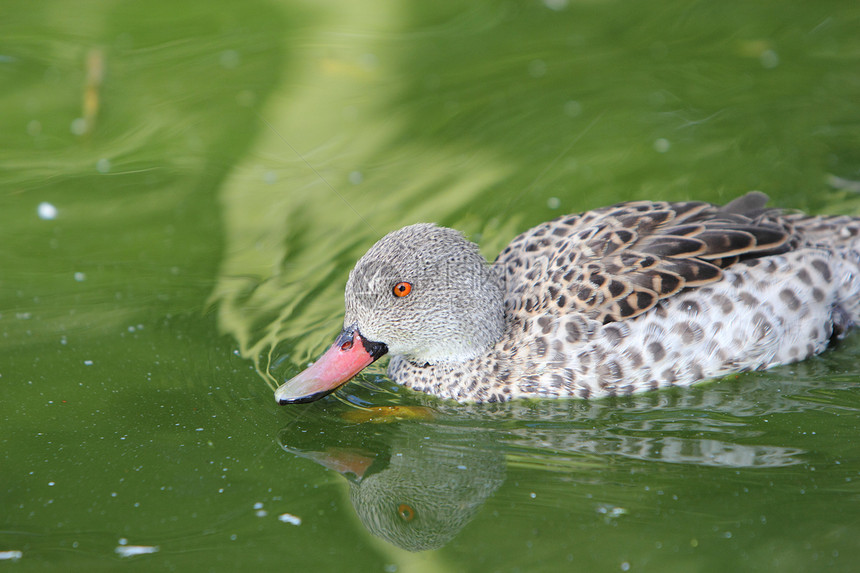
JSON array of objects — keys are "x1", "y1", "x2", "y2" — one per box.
[{"x1": 275, "y1": 223, "x2": 505, "y2": 404}]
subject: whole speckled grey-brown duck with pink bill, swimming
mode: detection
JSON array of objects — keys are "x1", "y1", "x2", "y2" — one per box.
[{"x1": 275, "y1": 191, "x2": 860, "y2": 404}]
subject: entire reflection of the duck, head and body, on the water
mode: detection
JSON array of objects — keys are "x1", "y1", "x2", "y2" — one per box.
[{"x1": 280, "y1": 378, "x2": 820, "y2": 551}]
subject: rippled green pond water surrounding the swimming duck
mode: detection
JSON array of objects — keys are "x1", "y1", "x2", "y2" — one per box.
[{"x1": 5, "y1": 0, "x2": 860, "y2": 572}]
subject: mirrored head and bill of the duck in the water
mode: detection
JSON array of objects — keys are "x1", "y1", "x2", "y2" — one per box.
[{"x1": 281, "y1": 416, "x2": 505, "y2": 551}]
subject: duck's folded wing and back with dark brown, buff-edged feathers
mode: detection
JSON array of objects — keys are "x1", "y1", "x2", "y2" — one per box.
[{"x1": 495, "y1": 192, "x2": 793, "y2": 323}]
